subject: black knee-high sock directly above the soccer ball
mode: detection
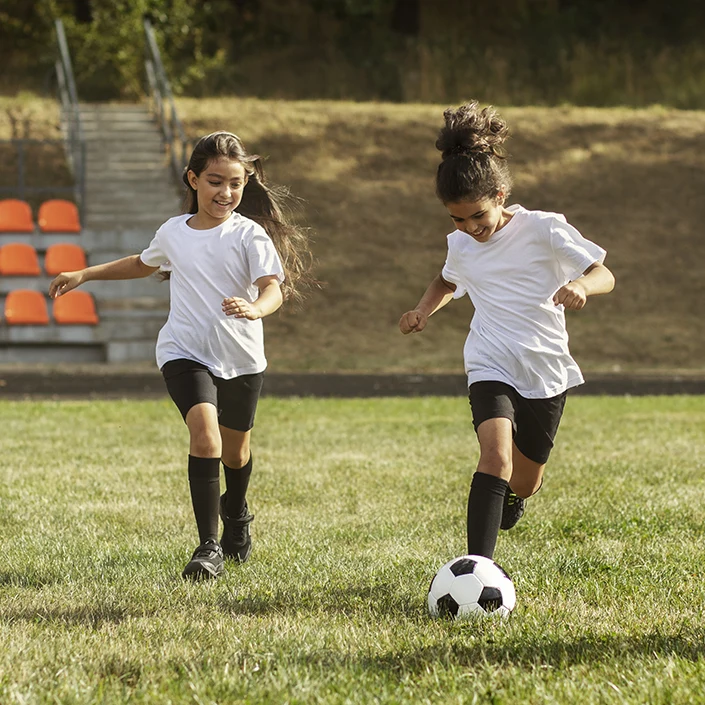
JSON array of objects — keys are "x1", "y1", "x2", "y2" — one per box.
[{"x1": 468, "y1": 472, "x2": 508, "y2": 558}]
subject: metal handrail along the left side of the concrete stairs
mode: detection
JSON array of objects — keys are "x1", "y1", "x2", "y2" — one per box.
[{"x1": 55, "y1": 18, "x2": 86, "y2": 218}]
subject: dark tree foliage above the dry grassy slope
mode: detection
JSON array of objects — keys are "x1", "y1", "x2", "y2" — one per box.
[{"x1": 0, "y1": 0, "x2": 705, "y2": 102}]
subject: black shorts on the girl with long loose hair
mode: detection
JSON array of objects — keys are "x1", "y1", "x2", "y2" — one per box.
[{"x1": 162, "y1": 359, "x2": 264, "y2": 431}]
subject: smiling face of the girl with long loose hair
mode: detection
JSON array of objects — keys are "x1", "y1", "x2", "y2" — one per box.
[{"x1": 188, "y1": 157, "x2": 247, "y2": 230}]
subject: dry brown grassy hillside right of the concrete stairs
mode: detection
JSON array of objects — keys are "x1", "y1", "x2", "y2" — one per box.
[{"x1": 178, "y1": 99, "x2": 705, "y2": 372}]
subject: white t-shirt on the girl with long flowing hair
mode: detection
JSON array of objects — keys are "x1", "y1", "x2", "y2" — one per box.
[{"x1": 140, "y1": 213, "x2": 284, "y2": 379}]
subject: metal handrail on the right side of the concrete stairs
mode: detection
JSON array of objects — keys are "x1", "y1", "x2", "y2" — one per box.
[{"x1": 144, "y1": 19, "x2": 188, "y2": 181}]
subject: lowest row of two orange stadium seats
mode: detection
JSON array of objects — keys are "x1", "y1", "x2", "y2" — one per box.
[{"x1": 4, "y1": 289, "x2": 99, "y2": 326}]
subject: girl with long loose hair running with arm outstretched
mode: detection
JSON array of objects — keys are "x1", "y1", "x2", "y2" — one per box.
[{"x1": 49, "y1": 132, "x2": 316, "y2": 580}]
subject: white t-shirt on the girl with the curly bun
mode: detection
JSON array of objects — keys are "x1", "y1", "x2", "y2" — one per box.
[{"x1": 442, "y1": 205, "x2": 606, "y2": 399}]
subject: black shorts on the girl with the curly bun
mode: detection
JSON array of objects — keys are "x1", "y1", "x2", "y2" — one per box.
[{"x1": 469, "y1": 382, "x2": 567, "y2": 465}]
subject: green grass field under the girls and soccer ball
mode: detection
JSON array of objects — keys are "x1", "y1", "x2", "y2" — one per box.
[{"x1": 0, "y1": 397, "x2": 705, "y2": 705}]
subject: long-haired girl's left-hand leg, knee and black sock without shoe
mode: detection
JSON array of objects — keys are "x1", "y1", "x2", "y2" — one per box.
[{"x1": 186, "y1": 402, "x2": 222, "y2": 544}]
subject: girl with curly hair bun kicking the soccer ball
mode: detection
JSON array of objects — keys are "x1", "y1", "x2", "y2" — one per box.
[{"x1": 399, "y1": 101, "x2": 614, "y2": 558}]
